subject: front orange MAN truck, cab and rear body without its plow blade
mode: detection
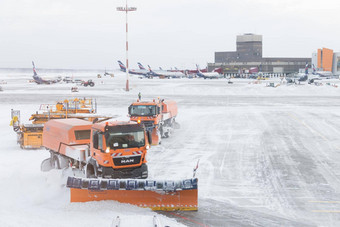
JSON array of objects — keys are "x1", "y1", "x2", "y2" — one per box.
[{"x1": 41, "y1": 118, "x2": 151, "y2": 179}]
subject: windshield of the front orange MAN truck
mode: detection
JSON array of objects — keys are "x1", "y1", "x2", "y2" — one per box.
[{"x1": 106, "y1": 131, "x2": 145, "y2": 149}]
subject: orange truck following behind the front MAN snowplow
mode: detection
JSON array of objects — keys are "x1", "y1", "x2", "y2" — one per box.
[{"x1": 129, "y1": 99, "x2": 179, "y2": 145}]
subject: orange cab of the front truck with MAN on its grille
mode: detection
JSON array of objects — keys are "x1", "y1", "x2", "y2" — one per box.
[{"x1": 90, "y1": 121, "x2": 151, "y2": 178}]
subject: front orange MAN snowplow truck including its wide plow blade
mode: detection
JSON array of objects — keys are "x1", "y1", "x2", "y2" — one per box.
[{"x1": 41, "y1": 119, "x2": 198, "y2": 211}]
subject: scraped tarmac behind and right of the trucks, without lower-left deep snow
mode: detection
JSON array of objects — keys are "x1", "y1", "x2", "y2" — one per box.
[{"x1": 1, "y1": 73, "x2": 340, "y2": 226}]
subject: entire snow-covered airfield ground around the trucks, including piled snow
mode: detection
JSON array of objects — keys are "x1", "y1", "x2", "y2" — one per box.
[{"x1": 0, "y1": 72, "x2": 340, "y2": 226}]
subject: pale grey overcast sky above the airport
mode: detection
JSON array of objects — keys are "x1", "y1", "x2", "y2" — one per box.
[{"x1": 0, "y1": 0, "x2": 340, "y2": 69}]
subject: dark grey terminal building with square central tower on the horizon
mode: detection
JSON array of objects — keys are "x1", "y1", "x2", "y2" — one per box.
[{"x1": 208, "y1": 33, "x2": 311, "y2": 74}]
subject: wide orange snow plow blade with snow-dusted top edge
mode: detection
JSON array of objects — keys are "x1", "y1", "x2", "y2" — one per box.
[{"x1": 67, "y1": 177, "x2": 198, "y2": 211}]
